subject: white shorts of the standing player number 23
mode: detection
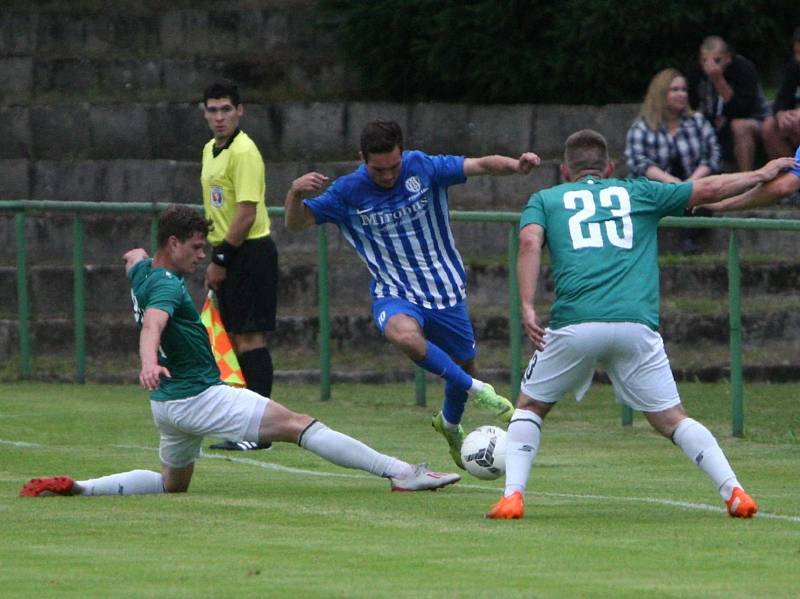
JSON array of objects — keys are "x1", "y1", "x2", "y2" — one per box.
[{"x1": 520, "y1": 322, "x2": 681, "y2": 412}]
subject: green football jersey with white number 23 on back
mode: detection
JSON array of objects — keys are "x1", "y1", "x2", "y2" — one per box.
[{"x1": 520, "y1": 176, "x2": 692, "y2": 330}]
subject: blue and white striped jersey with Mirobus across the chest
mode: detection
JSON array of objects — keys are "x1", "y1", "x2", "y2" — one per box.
[{"x1": 304, "y1": 151, "x2": 466, "y2": 309}]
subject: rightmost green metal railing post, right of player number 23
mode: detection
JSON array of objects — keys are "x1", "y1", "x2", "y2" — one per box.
[{"x1": 728, "y1": 229, "x2": 744, "y2": 437}]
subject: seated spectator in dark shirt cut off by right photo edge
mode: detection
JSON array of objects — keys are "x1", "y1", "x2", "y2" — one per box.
[{"x1": 761, "y1": 27, "x2": 800, "y2": 158}]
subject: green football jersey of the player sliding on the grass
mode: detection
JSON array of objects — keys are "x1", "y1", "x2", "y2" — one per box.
[{"x1": 128, "y1": 258, "x2": 222, "y2": 401}]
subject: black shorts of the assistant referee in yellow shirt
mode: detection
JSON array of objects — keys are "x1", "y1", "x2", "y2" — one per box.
[{"x1": 217, "y1": 235, "x2": 278, "y2": 333}]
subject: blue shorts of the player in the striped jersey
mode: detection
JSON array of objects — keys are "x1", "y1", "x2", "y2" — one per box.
[{"x1": 372, "y1": 297, "x2": 475, "y2": 362}]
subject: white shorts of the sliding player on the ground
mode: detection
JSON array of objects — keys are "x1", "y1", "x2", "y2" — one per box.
[{"x1": 150, "y1": 385, "x2": 270, "y2": 468}]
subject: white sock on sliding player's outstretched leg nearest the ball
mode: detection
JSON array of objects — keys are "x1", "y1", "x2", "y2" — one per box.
[{"x1": 298, "y1": 420, "x2": 414, "y2": 478}]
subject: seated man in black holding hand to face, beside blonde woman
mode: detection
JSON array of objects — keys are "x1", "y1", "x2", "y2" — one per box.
[{"x1": 689, "y1": 35, "x2": 769, "y2": 171}]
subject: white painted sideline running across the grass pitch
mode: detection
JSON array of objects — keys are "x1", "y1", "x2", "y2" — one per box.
[{"x1": 12, "y1": 439, "x2": 800, "y2": 522}]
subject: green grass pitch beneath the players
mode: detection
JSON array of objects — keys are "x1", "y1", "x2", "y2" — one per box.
[{"x1": 0, "y1": 383, "x2": 800, "y2": 599}]
